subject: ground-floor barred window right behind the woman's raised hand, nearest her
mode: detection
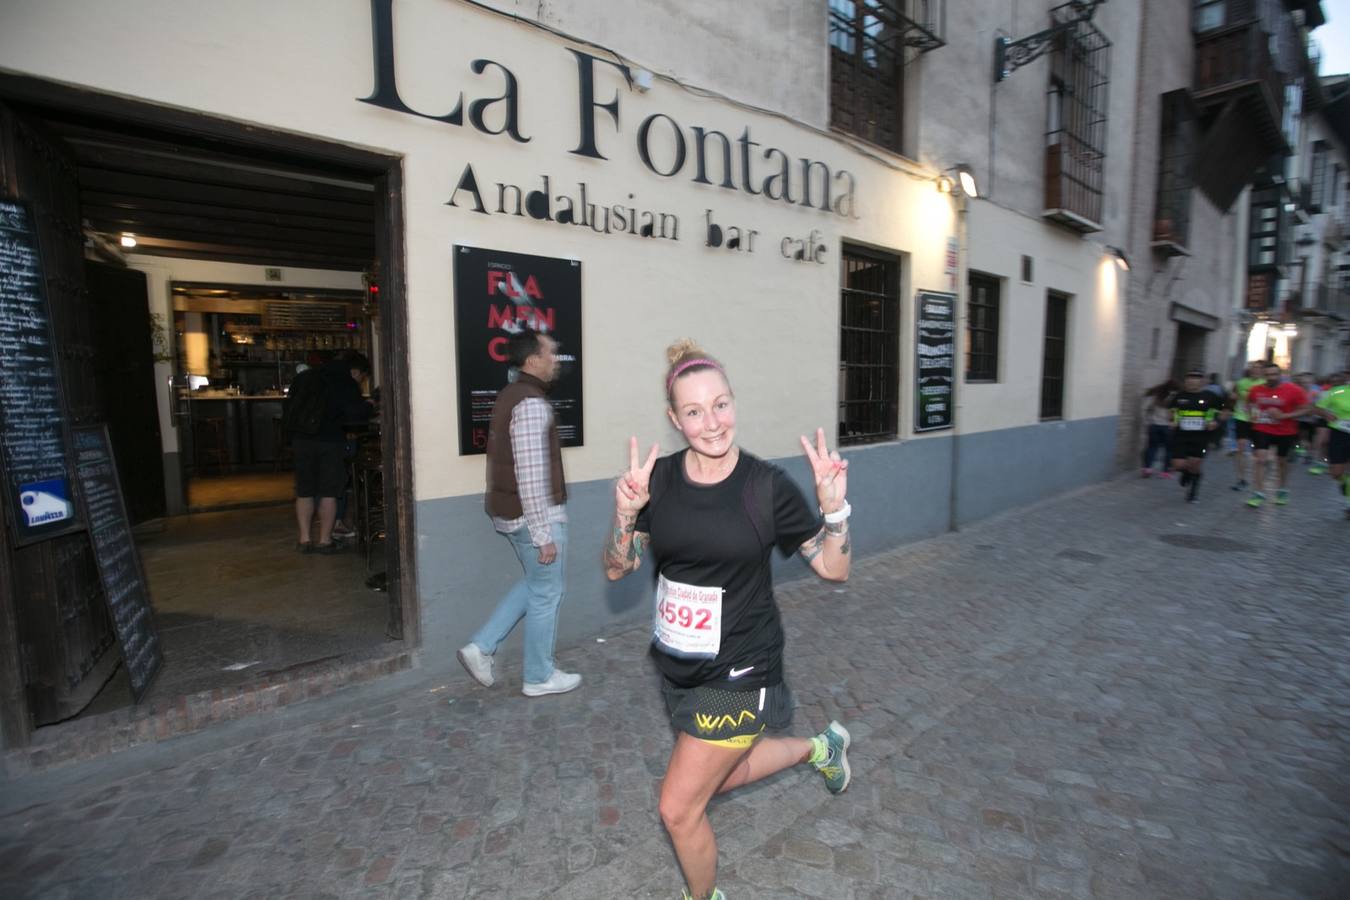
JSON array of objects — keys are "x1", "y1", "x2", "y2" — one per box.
[{"x1": 838, "y1": 247, "x2": 900, "y2": 445}]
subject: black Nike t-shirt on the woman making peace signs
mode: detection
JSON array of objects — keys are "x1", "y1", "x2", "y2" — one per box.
[{"x1": 636, "y1": 449, "x2": 824, "y2": 691}]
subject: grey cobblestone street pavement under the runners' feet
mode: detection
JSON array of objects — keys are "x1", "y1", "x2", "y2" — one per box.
[{"x1": 0, "y1": 467, "x2": 1350, "y2": 900}]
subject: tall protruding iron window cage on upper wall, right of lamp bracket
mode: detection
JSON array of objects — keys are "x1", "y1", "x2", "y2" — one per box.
[{"x1": 1045, "y1": 1, "x2": 1111, "y2": 232}]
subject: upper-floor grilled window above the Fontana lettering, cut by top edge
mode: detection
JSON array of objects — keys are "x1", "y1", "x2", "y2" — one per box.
[{"x1": 829, "y1": 0, "x2": 945, "y2": 152}]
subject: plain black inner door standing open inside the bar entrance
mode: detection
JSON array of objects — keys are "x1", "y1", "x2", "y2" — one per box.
[{"x1": 85, "y1": 262, "x2": 165, "y2": 525}]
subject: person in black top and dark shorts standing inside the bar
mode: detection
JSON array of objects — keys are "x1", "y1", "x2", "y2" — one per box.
[{"x1": 281, "y1": 351, "x2": 373, "y2": 553}]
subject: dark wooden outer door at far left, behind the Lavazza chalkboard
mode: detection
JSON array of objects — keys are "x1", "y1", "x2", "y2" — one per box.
[{"x1": 0, "y1": 104, "x2": 119, "y2": 746}]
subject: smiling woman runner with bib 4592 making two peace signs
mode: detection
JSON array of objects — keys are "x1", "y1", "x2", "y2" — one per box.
[{"x1": 605, "y1": 340, "x2": 852, "y2": 900}]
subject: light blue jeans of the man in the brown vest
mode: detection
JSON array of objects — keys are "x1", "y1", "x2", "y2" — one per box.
[{"x1": 473, "y1": 522, "x2": 567, "y2": 684}]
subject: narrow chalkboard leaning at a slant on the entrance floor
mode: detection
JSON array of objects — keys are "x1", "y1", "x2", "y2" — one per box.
[{"x1": 72, "y1": 425, "x2": 163, "y2": 702}]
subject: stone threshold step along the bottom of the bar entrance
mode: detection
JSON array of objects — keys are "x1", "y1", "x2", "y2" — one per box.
[{"x1": 0, "y1": 650, "x2": 413, "y2": 777}]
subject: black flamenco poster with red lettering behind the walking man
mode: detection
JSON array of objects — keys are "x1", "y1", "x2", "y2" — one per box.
[{"x1": 455, "y1": 246, "x2": 585, "y2": 456}]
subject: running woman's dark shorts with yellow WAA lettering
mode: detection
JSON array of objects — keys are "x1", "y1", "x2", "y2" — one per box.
[{"x1": 662, "y1": 681, "x2": 792, "y2": 750}]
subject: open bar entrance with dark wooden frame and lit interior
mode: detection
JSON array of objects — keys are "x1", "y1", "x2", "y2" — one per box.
[{"x1": 0, "y1": 76, "x2": 417, "y2": 746}]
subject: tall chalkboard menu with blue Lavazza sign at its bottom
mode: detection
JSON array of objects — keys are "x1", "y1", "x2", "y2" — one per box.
[{"x1": 0, "y1": 200, "x2": 84, "y2": 544}]
